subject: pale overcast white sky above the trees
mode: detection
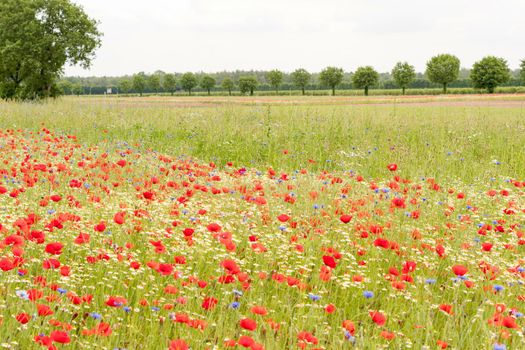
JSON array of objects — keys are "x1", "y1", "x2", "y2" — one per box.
[{"x1": 65, "y1": 0, "x2": 525, "y2": 76}]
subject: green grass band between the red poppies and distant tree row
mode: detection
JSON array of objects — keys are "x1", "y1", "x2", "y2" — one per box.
[{"x1": 0, "y1": 95, "x2": 525, "y2": 181}]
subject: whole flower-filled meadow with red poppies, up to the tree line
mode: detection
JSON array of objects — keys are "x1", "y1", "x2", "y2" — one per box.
[{"x1": 0, "y1": 95, "x2": 525, "y2": 349}]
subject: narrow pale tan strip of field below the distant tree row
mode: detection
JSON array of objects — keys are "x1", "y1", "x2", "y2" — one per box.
[{"x1": 72, "y1": 94, "x2": 525, "y2": 108}]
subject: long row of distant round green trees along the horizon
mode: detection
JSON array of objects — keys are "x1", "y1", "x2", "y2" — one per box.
[{"x1": 59, "y1": 54, "x2": 525, "y2": 95}]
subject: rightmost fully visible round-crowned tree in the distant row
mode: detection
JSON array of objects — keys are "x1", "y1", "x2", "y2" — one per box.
[{"x1": 470, "y1": 56, "x2": 510, "y2": 94}]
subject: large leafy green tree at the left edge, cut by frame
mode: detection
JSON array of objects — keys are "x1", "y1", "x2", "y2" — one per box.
[{"x1": 0, "y1": 0, "x2": 101, "y2": 99}]
